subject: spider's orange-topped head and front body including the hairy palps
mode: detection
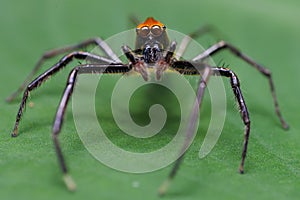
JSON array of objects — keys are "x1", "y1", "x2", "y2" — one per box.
[{"x1": 123, "y1": 17, "x2": 176, "y2": 81}]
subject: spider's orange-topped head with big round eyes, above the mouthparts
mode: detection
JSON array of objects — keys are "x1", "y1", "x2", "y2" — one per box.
[{"x1": 135, "y1": 17, "x2": 169, "y2": 54}]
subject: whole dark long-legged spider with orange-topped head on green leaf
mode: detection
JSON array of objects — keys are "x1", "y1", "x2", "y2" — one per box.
[{"x1": 7, "y1": 17, "x2": 288, "y2": 194}]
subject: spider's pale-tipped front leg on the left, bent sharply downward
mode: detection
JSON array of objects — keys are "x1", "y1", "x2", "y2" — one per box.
[{"x1": 52, "y1": 64, "x2": 130, "y2": 191}]
